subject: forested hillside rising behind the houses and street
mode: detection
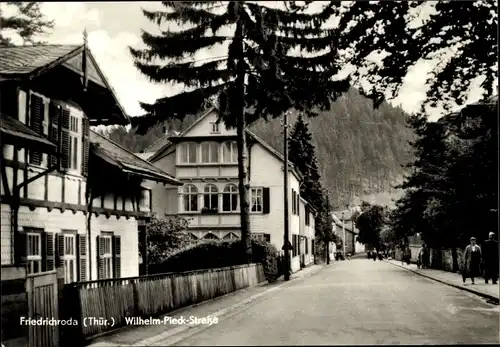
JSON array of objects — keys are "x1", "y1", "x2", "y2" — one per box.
[{"x1": 99, "y1": 90, "x2": 414, "y2": 209}]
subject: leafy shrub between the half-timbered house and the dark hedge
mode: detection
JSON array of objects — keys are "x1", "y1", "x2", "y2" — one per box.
[{"x1": 143, "y1": 216, "x2": 193, "y2": 264}]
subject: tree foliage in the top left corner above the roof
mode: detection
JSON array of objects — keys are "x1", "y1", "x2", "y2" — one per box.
[{"x1": 0, "y1": 2, "x2": 54, "y2": 46}]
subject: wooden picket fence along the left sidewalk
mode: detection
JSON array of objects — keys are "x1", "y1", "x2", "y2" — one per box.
[{"x1": 64, "y1": 264, "x2": 266, "y2": 342}]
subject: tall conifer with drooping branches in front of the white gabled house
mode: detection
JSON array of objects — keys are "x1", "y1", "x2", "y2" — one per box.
[{"x1": 130, "y1": 1, "x2": 349, "y2": 261}]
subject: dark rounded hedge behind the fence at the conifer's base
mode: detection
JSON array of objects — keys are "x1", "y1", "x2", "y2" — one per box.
[{"x1": 148, "y1": 240, "x2": 280, "y2": 282}]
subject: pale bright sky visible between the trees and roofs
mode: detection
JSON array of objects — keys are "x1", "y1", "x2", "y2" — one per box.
[{"x1": 0, "y1": 2, "x2": 492, "y2": 120}]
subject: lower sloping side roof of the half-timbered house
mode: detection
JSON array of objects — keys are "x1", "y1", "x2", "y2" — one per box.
[{"x1": 90, "y1": 131, "x2": 182, "y2": 185}]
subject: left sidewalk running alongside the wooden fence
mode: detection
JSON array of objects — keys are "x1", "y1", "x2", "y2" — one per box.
[{"x1": 89, "y1": 264, "x2": 326, "y2": 347}]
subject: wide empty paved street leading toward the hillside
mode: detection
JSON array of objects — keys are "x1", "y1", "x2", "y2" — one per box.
[{"x1": 166, "y1": 259, "x2": 499, "y2": 346}]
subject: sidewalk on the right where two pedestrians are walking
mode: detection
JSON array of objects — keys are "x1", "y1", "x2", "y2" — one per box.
[{"x1": 384, "y1": 259, "x2": 500, "y2": 303}]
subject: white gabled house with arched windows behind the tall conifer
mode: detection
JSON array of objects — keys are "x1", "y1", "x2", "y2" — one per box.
[{"x1": 148, "y1": 108, "x2": 314, "y2": 271}]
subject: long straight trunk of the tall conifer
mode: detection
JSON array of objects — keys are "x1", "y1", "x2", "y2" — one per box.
[{"x1": 233, "y1": 14, "x2": 252, "y2": 263}]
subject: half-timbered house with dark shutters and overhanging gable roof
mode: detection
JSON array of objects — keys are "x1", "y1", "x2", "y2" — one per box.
[{"x1": 0, "y1": 45, "x2": 181, "y2": 283}]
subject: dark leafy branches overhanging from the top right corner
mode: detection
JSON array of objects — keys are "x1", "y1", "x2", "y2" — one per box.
[{"x1": 337, "y1": 0, "x2": 498, "y2": 107}]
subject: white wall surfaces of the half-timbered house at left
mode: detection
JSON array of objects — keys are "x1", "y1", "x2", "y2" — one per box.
[{"x1": 0, "y1": 84, "x2": 150, "y2": 279}]
